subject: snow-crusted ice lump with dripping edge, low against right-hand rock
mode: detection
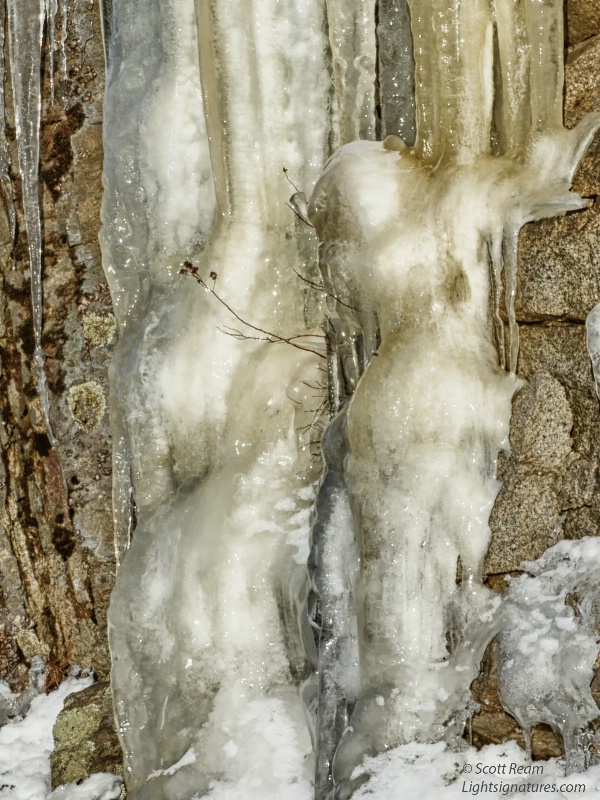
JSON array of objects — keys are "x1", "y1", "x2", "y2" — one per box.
[{"x1": 498, "y1": 537, "x2": 600, "y2": 772}]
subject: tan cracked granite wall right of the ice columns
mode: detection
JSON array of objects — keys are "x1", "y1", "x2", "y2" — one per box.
[{"x1": 474, "y1": 15, "x2": 600, "y2": 758}]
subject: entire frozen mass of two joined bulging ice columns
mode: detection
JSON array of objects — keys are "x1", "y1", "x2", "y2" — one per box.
[{"x1": 96, "y1": 0, "x2": 599, "y2": 800}]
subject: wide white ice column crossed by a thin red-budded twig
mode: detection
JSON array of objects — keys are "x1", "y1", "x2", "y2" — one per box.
[{"x1": 102, "y1": 0, "x2": 330, "y2": 800}]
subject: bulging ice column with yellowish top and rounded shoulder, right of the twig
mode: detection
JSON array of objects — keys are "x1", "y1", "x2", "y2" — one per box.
[{"x1": 309, "y1": 0, "x2": 599, "y2": 798}]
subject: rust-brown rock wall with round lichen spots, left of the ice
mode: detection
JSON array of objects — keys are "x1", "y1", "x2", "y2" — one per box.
[{"x1": 0, "y1": 0, "x2": 115, "y2": 688}]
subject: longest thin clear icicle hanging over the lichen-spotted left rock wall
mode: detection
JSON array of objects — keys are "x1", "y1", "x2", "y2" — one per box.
[{"x1": 8, "y1": 0, "x2": 56, "y2": 445}]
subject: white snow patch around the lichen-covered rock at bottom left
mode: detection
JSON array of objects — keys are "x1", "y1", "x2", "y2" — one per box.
[{"x1": 0, "y1": 677, "x2": 122, "y2": 800}]
